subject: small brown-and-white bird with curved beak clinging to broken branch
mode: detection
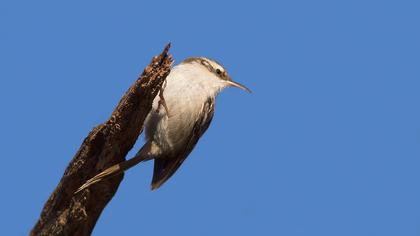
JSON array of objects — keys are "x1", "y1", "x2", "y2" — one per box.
[{"x1": 75, "y1": 57, "x2": 251, "y2": 193}]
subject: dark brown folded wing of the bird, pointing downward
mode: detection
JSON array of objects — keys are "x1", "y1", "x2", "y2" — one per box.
[{"x1": 152, "y1": 98, "x2": 214, "y2": 189}]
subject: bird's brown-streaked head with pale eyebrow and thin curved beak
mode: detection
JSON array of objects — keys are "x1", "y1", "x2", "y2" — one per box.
[{"x1": 181, "y1": 57, "x2": 251, "y2": 93}]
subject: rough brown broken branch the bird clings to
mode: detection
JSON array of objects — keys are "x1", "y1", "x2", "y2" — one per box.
[{"x1": 30, "y1": 44, "x2": 173, "y2": 235}]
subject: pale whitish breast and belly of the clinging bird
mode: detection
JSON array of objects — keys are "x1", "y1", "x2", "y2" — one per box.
[{"x1": 145, "y1": 64, "x2": 224, "y2": 152}]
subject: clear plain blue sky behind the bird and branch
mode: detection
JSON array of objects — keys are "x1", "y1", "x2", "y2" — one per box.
[{"x1": 0, "y1": 1, "x2": 420, "y2": 236}]
